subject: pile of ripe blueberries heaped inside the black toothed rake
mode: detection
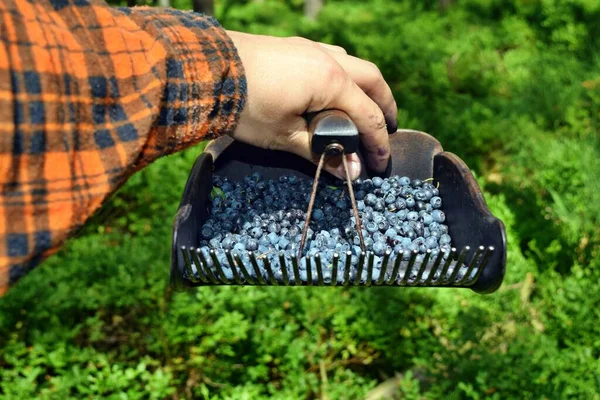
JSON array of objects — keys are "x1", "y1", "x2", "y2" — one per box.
[{"x1": 199, "y1": 173, "x2": 460, "y2": 280}]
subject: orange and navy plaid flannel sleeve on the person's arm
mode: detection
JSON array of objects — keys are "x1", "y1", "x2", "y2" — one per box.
[{"x1": 0, "y1": 0, "x2": 247, "y2": 296}]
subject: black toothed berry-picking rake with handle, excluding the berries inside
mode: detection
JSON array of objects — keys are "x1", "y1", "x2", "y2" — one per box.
[{"x1": 171, "y1": 110, "x2": 506, "y2": 294}]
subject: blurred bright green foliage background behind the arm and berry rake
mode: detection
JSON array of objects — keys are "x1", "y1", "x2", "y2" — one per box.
[{"x1": 0, "y1": 0, "x2": 600, "y2": 399}]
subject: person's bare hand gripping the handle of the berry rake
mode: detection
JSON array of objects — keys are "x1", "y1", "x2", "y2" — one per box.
[{"x1": 228, "y1": 31, "x2": 398, "y2": 180}]
